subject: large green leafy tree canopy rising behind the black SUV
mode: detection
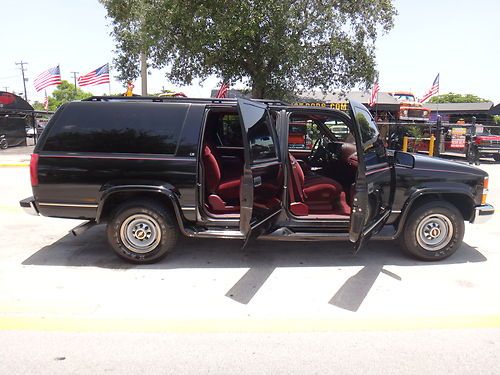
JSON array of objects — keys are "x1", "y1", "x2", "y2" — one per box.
[{"x1": 100, "y1": 0, "x2": 396, "y2": 98}]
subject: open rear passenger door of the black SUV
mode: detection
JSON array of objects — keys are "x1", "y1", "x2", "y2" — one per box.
[{"x1": 238, "y1": 99, "x2": 283, "y2": 241}]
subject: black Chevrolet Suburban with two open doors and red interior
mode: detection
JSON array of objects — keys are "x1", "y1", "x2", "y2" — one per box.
[{"x1": 20, "y1": 97, "x2": 494, "y2": 263}]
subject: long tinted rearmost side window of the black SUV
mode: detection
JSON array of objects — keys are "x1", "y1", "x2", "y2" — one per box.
[{"x1": 43, "y1": 102, "x2": 188, "y2": 154}]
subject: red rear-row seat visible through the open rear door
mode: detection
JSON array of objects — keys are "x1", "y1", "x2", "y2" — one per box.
[{"x1": 203, "y1": 144, "x2": 241, "y2": 213}]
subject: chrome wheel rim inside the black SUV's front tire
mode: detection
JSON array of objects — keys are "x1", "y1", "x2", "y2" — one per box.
[{"x1": 416, "y1": 214, "x2": 453, "y2": 251}]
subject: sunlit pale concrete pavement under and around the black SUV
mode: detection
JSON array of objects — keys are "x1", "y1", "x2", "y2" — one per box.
[{"x1": 0, "y1": 147, "x2": 500, "y2": 374}]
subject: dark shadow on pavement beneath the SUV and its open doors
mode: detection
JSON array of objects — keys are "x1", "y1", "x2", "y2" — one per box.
[{"x1": 22, "y1": 226, "x2": 487, "y2": 311}]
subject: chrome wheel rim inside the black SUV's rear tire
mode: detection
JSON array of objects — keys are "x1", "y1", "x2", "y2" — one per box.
[{"x1": 120, "y1": 214, "x2": 161, "y2": 254}]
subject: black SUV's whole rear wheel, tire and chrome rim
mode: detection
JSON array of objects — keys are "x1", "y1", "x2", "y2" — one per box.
[{"x1": 107, "y1": 200, "x2": 178, "y2": 264}]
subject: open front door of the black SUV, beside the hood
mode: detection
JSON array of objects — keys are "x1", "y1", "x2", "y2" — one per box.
[{"x1": 349, "y1": 101, "x2": 394, "y2": 253}]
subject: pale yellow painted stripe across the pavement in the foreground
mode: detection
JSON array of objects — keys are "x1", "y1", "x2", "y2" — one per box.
[{"x1": 0, "y1": 315, "x2": 500, "y2": 333}]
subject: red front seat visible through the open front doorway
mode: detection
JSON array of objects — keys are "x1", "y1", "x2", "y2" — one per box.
[{"x1": 290, "y1": 155, "x2": 346, "y2": 216}]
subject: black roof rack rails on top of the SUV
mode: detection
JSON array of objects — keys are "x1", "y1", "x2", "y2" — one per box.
[{"x1": 82, "y1": 96, "x2": 288, "y2": 105}]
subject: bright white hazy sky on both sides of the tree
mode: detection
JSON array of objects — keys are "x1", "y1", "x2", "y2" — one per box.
[{"x1": 0, "y1": 0, "x2": 500, "y2": 103}]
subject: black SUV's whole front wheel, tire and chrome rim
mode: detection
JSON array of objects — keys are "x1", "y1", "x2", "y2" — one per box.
[{"x1": 400, "y1": 201, "x2": 465, "y2": 261}]
